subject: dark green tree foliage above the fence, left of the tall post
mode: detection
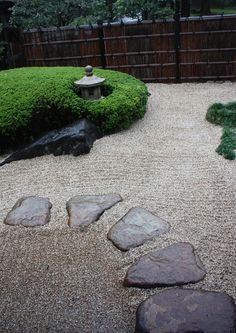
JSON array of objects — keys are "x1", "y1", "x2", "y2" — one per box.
[{"x1": 11, "y1": 0, "x2": 173, "y2": 28}]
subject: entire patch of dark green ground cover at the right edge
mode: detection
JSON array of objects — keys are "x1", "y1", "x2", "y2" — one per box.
[{"x1": 206, "y1": 102, "x2": 236, "y2": 160}]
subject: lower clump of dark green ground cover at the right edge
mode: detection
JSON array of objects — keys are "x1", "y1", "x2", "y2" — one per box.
[{"x1": 216, "y1": 127, "x2": 236, "y2": 160}]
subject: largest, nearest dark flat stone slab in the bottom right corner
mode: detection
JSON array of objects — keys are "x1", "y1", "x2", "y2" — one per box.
[{"x1": 135, "y1": 288, "x2": 236, "y2": 333}]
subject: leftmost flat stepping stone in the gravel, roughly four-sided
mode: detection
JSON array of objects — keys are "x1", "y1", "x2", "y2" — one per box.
[{"x1": 4, "y1": 196, "x2": 52, "y2": 227}]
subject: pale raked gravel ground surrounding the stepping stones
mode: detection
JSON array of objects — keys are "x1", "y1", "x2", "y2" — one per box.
[{"x1": 0, "y1": 82, "x2": 236, "y2": 333}]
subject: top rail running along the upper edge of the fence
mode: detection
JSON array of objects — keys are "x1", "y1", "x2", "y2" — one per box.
[{"x1": 23, "y1": 14, "x2": 236, "y2": 34}]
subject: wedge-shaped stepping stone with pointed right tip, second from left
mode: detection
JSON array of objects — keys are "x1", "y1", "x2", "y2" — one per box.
[{"x1": 66, "y1": 194, "x2": 122, "y2": 230}]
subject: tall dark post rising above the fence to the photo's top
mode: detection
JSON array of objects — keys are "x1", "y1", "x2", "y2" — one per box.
[{"x1": 174, "y1": 0, "x2": 181, "y2": 83}]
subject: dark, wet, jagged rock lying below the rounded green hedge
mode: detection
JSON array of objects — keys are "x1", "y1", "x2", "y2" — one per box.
[{"x1": 0, "y1": 119, "x2": 102, "y2": 166}]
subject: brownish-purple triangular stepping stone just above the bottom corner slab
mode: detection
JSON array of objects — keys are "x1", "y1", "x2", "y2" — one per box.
[{"x1": 124, "y1": 243, "x2": 206, "y2": 288}]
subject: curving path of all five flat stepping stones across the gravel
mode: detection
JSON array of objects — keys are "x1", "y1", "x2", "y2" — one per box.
[{"x1": 4, "y1": 194, "x2": 236, "y2": 333}]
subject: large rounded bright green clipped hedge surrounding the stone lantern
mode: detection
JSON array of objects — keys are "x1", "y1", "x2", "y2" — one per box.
[{"x1": 0, "y1": 67, "x2": 148, "y2": 150}]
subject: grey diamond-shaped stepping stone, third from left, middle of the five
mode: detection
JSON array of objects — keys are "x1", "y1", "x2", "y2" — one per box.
[{"x1": 107, "y1": 207, "x2": 170, "y2": 251}]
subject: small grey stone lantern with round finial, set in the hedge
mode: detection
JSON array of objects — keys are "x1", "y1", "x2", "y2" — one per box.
[{"x1": 74, "y1": 66, "x2": 105, "y2": 100}]
